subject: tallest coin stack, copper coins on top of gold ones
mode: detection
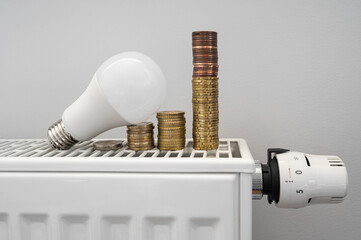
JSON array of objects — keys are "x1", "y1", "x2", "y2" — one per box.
[{"x1": 192, "y1": 31, "x2": 219, "y2": 150}]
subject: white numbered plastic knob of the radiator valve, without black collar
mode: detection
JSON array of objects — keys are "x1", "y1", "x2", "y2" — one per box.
[{"x1": 276, "y1": 151, "x2": 348, "y2": 208}]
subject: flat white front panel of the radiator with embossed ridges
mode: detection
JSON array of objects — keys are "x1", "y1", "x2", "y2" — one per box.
[{"x1": 0, "y1": 173, "x2": 239, "y2": 240}]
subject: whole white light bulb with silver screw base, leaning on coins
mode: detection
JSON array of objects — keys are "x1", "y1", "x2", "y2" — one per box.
[{"x1": 48, "y1": 52, "x2": 166, "y2": 149}]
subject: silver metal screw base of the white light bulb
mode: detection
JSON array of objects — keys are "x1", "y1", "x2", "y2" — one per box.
[{"x1": 48, "y1": 119, "x2": 79, "y2": 150}]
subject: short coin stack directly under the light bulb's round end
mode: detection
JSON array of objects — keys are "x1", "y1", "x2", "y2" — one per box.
[{"x1": 127, "y1": 122, "x2": 154, "y2": 151}]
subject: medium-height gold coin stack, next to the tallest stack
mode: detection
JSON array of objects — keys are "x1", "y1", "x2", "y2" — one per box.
[{"x1": 157, "y1": 111, "x2": 186, "y2": 151}]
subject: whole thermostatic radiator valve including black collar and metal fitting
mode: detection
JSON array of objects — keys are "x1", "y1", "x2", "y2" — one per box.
[{"x1": 252, "y1": 148, "x2": 348, "y2": 208}]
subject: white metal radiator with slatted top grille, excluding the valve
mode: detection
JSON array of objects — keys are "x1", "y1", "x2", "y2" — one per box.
[{"x1": 0, "y1": 139, "x2": 255, "y2": 240}]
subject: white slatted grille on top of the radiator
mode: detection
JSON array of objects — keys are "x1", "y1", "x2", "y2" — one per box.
[{"x1": 0, "y1": 139, "x2": 241, "y2": 158}]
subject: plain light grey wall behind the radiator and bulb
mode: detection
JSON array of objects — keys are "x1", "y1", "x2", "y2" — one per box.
[{"x1": 0, "y1": 0, "x2": 361, "y2": 240}]
